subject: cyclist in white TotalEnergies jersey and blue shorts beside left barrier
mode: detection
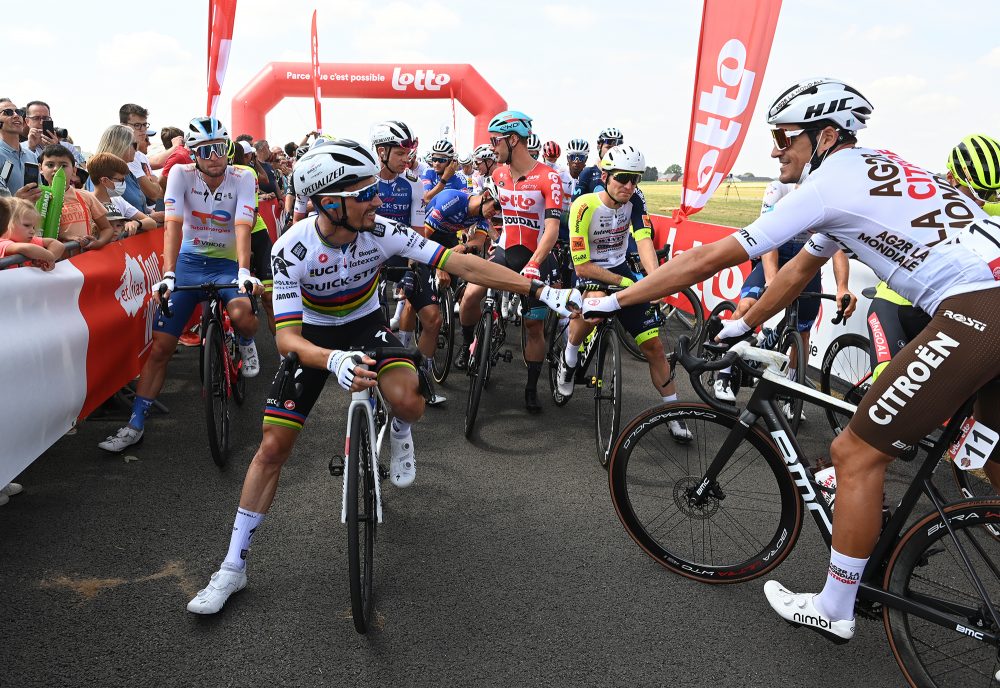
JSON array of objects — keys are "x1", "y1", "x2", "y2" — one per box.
[{"x1": 98, "y1": 117, "x2": 264, "y2": 452}]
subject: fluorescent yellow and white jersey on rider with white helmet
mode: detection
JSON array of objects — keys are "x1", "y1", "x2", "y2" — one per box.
[{"x1": 569, "y1": 193, "x2": 653, "y2": 268}]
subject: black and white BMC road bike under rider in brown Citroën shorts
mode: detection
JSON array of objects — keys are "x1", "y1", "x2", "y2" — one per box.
[{"x1": 609, "y1": 332, "x2": 1000, "y2": 688}]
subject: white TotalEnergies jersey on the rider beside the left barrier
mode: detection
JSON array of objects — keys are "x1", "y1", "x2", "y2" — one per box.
[{"x1": 163, "y1": 163, "x2": 257, "y2": 260}]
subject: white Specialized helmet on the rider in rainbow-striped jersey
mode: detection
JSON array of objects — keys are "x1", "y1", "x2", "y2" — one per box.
[{"x1": 292, "y1": 139, "x2": 379, "y2": 196}]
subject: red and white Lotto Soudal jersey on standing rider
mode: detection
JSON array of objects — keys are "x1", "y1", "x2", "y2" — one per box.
[{"x1": 493, "y1": 162, "x2": 562, "y2": 251}]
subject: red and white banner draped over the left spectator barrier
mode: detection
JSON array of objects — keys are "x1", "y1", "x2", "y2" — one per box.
[{"x1": 0, "y1": 230, "x2": 163, "y2": 485}]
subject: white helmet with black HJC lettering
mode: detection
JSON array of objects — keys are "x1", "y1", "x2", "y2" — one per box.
[{"x1": 767, "y1": 77, "x2": 875, "y2": 134}]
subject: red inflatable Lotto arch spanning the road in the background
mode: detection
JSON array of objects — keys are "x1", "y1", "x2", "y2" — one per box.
[{"x1": 230, "y1": 62, "x2": 507, "y2": 145}]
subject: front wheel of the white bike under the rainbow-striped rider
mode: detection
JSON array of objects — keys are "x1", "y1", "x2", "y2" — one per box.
[{"x1": 347, "y1": 409, "x2": 378, "y2": 633}]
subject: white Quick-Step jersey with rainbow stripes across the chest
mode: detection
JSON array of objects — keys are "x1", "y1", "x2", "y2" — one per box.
[{"x1": 271, "y1": 215, "x2": 451, "y2": 330}]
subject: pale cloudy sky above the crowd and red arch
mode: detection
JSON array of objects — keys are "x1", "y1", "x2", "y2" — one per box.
[{"x1": 0, "y1": 0, "x2": 1000, "y2": 176}]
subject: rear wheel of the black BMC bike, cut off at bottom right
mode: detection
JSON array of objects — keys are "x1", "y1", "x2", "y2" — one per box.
[{"x1": 882, "y1": 499, "x2": 1000, "y2": 688}]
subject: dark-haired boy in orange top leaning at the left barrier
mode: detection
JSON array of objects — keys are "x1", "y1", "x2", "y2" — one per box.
[{"x1": 38, "y1": 143, "x2": 114, "y2": 249}]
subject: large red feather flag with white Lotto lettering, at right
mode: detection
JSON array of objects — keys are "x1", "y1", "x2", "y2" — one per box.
[{"x1": 675, "y1": 0, "x2": 781, "y2": 220}]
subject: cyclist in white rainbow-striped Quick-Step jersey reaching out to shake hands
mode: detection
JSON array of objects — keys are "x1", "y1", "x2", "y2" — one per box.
[{"x1": 187, "y1": 139, "x2": 580, "y2": 614}]
